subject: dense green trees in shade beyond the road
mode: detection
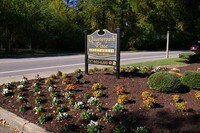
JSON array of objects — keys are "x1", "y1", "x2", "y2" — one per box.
[{"x1": 0, "y1": 0, "x2": 200, "y2": 51}]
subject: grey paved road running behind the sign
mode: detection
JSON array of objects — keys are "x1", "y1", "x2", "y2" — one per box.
[{"x1": 0, "y1": 51, "x2": 183, "y2": 78}]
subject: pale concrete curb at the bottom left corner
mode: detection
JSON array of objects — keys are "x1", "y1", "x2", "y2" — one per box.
[{"x1": 0, "y1": 107, "x2": 50, "y2": 133}]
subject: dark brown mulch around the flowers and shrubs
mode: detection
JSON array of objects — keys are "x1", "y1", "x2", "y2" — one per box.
[{"x1": 0, "y1": 63, "x2": 200, "y2": 133}]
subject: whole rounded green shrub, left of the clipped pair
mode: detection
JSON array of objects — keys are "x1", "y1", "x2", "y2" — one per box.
[{"x1": 147, "y1": 72, "x2": 182, "y2": 92}]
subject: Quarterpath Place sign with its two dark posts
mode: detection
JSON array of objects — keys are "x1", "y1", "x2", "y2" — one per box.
[{"x1": 85, "y1": 27, "x2": 120, "y2": 78}]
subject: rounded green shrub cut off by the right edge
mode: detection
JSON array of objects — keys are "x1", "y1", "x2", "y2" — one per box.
[{"x1": 181, "y1": 71, "x2": 200, "y2": 90}]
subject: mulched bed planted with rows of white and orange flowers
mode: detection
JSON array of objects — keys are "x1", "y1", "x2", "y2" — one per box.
[{"x1": 0, "y1": 64, "x2": 200, "y2": 133}]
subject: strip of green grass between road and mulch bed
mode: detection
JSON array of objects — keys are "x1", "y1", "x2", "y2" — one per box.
[{"x1": 122, "y1": 58, "x2": 186, "y2": 67}]
